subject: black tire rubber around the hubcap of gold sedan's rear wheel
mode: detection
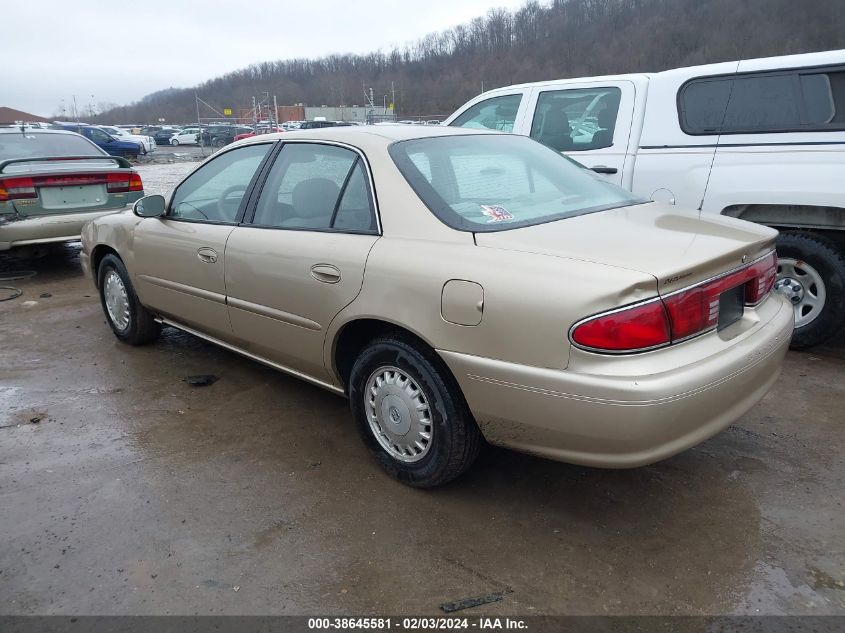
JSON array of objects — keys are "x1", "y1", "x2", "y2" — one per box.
[{"x1": 349, "y1": 336, "x2": 482, "y2": 488}]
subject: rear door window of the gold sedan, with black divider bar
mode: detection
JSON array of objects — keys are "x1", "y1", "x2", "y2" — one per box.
[{"x1": 253, "y1": 143, "x2": 376, "y2": 233}]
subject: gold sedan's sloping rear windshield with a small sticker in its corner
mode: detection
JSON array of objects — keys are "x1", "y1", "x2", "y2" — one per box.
[{"x1": 389, "y1": 134, "x2": 646, "y2": 232}]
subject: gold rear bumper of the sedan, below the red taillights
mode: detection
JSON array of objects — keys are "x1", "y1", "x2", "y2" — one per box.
[{"x1": 439, "y1": 295, "x2": 793, "y2": 468}]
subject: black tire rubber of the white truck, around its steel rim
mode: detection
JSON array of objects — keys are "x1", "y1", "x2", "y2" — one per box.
[{"x1": 777, "y1": 231, "x2": 845, "y2": 349}]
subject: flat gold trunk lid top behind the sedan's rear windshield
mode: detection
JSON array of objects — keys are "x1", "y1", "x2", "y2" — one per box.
[{"x1": 475, "y1": 203, "x2": 777, "y2": 295}]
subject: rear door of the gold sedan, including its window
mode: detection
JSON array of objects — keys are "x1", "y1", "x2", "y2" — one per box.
[{"x1": 226, "y1": 142, "x2": 379, "y2": 382}]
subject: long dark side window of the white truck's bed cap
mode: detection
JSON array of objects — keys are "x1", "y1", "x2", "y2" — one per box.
[{"x1": 678, "y1": 70, "x2": 845, "y2": 135}]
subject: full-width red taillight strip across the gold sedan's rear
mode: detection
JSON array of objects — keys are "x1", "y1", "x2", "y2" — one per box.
[{"x1": 570, "y1": 251, "x2": 777, "y2": 353}]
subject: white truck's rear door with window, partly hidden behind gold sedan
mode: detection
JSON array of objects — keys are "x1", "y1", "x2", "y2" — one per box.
[{"x1": 514, "y1": 80, "x2": 636, "y2": 185}]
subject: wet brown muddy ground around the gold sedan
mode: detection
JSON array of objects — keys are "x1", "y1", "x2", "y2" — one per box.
[{"x1": 0, "y1": 184, "x2": 845, "y2": 615}]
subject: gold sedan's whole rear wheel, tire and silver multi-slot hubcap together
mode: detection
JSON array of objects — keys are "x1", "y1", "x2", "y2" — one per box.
[{"x1": 349, "y1": 336, "x2": 481, "y2": 488}]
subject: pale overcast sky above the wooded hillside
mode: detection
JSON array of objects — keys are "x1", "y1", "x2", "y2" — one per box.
[{"x1": 0, "y1": 0, "x2": 525, "y2": 116}]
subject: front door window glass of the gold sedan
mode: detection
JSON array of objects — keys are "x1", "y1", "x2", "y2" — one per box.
[{"x1": 168, "y1": 143, "x2": 272, "y2": 224}]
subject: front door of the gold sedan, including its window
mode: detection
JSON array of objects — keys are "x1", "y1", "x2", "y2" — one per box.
[{"x1": 131, "y1": 143, "x2": 272, "y2": 339}]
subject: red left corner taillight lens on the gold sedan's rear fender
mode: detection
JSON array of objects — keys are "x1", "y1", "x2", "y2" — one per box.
[{"x1": 572, "y1": 299, "x2": 671, "y2": 352}]
